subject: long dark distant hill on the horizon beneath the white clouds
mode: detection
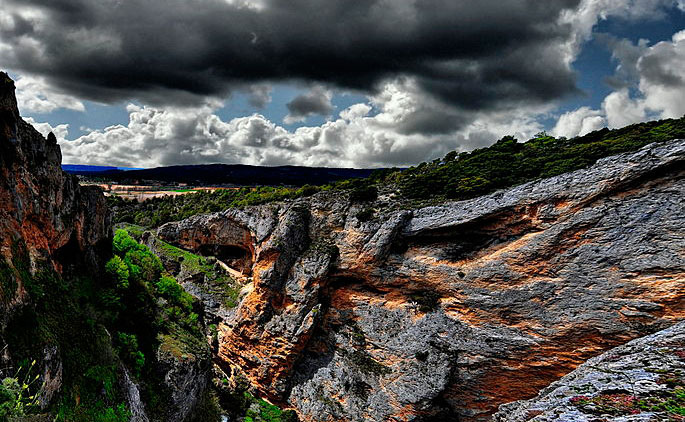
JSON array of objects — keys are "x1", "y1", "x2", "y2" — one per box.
[{"x1": 63, "y1": 164, "x2": 373, "y2": 186}]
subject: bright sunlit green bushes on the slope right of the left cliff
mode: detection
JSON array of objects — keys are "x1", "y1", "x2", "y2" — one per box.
[{"x1": 104, "y1": 230, "x2": 209, "y2": 364}]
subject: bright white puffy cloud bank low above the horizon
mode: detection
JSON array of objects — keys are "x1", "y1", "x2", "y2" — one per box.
[{"x1": 61, "y1": 81, "x2": 542, "y2": 167}]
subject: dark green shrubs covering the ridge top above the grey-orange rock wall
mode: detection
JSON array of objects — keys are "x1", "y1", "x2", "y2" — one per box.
[{"x1": 386, "y1": 118, "x2": 685, "y2": 199}]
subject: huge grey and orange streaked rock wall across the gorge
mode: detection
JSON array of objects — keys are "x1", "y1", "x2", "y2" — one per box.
[{"x1": 158, "y1": 141, "x2": 685, "y2": 421}]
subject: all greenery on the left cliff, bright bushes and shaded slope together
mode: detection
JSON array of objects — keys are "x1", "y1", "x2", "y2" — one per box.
[{"x1": 0, "y1": 230, "x2": 210, "y2": 422}]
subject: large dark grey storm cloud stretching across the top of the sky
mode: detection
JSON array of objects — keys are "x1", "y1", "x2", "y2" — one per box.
[{"x1": 0, "y1": 0, "x2": 579, "y2": 110}]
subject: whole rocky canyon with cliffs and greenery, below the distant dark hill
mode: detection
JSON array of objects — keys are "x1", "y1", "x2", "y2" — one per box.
[{"x1": 0, "y1": 74, "x2": 685, "y2": 422}]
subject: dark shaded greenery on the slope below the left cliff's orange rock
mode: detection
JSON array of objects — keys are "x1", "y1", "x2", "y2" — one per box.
[{"x1": 0, "y1": 240, "x2": 129, "y2": 422}]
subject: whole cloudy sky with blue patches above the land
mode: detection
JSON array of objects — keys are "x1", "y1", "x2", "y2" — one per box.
[{"x1": 0, "y1": 0, "x2": 685, "y2": 168}]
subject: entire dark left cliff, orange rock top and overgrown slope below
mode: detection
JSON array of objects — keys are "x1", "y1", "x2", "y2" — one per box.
[{"x1": 0, "y1": 73, "x2": 212, "y2": 422}]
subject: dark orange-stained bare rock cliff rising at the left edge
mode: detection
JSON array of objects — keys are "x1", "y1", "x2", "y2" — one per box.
[{"x1": 0, "y1": 72, "x2": 111, "y2": 320}]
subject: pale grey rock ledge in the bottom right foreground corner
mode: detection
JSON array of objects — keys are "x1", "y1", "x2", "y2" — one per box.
[{"x1": 494, "y1": 323, "x2": 685, "y2": 422}]
